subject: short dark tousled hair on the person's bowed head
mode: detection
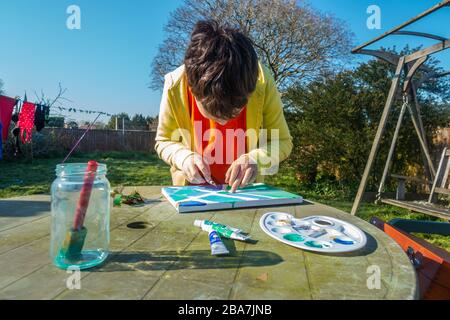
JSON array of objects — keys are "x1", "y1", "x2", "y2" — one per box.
[{"x1": 184, "y1": 20, "x2": 258, "y2": 120}]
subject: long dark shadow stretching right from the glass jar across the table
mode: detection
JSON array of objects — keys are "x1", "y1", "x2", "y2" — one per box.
[{"x1": 93, "y1": 250, "x2": 283, "y2": 272}]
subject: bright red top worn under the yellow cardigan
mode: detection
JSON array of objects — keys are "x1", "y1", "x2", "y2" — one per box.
[{"x1": 188, "y1": 89, "x2": 247, "y2": 184}]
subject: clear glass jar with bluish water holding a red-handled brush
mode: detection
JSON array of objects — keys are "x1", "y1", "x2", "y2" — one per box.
[{"x1": 50, "y1": 162, "x2": 111, "y2": 270}]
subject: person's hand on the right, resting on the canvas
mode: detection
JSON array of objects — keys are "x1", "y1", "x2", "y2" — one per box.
[{"x1": 225, "y1": 154, "x2": 258, "y2": 193}]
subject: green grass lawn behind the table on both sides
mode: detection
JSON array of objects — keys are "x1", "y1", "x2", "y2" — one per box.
[{"x1": 0, "y1": 152, "x2": 450, "y2": 251}]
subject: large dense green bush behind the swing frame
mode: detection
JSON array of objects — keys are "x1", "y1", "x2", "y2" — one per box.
[{"x1": 284, "y1": 48, "x2": 450, "y2": 190}]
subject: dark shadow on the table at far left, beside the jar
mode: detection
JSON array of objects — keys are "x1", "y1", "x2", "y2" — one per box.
[{"x1": 0, "y1": 200, "x2": 50, "y2": 218}]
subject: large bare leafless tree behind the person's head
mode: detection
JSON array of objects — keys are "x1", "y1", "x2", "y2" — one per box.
[{"x1": 151, "y1": 0, "x2": 353, "y2": 90}]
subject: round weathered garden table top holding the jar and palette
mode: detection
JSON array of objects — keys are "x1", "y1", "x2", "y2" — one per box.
[{"x1": 0, "y1": 187, "x2": 418, "y2": 300}]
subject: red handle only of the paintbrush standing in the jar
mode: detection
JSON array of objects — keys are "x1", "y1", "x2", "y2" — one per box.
[{"x1": 73, "y1": 161, "x2": 98, "y2": 231}]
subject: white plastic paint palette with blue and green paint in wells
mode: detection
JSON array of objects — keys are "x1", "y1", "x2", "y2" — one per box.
[{"x1": 259, "y1": 212, "x2": 367, "y2": 253}]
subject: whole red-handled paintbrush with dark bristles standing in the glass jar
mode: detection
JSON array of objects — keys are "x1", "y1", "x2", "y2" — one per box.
[{"x1": 61, "y1": 161, "x2": 98, "y2": 260}]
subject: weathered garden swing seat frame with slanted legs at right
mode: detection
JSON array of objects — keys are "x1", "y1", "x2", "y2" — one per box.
[{"x1": 351, "y1": 0, "x2": 450, "y2": 219}]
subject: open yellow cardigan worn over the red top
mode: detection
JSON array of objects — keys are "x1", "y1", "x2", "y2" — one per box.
[{"x1": 155, "y1": 63, "x2": 292, "y2": 185}]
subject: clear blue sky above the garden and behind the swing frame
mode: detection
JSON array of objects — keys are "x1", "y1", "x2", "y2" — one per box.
[{"x1": 0, "y1": 0, "x2": 450, "y2": 121}]
